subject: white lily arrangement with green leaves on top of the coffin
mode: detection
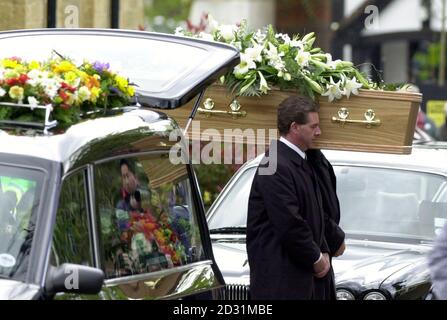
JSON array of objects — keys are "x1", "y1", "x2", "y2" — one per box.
[{"x1": 176, "y1": 15, "x2": 392, "y2": 102}]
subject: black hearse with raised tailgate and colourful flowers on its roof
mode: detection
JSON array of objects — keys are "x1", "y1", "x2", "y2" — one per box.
[{"x1": 0, "y1": 29, "x2": 239, "y2": 299}]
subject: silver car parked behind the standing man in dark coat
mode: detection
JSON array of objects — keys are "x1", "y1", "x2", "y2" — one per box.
[{"x1": 207, "y1": 146, "x2": 447, "y2": 300}]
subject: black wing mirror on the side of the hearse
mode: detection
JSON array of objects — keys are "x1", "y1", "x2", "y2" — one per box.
[{"x1": 45, "y1": 263, "x2": 104, "y2": 294}]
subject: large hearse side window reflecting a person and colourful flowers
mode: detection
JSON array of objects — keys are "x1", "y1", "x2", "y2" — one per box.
[{"x1": 95, "y1": 154, "x2": 204, "y2": 278}]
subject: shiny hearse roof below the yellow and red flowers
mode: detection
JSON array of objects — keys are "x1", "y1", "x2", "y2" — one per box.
[{"x1": 0, "y1": 108, "x2": 179, "y2": 173}]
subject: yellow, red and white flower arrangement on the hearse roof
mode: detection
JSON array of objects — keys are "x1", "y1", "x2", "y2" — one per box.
[{"x1": 0, "y1": 53, "x2": 135, "y2": 126}]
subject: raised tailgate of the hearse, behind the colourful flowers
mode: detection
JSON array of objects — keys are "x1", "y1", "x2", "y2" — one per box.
[{"x1": 0, "y1": 29, "x2": 240, "y2": 108}]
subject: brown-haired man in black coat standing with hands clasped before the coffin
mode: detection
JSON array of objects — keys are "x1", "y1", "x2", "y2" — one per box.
[{"x1": 247, "y1": 96, "x2": 344, "y2": 299}]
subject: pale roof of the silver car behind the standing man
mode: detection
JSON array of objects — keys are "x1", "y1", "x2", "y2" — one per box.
[{"x1": 246, "y1": 143, "x2": 447, "y2": 175}]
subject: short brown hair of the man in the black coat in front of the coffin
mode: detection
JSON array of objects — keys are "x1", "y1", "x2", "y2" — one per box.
[{"x1": 278, "y1": 96, "x2": 320, "y2": 135}]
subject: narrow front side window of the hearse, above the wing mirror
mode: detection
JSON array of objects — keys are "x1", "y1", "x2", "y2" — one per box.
[{"x1": 51, "y1": 172, "x2": 93, "y2": 266}]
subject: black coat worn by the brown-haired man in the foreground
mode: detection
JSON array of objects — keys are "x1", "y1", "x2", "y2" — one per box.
[{"x1": 247, "y1": 141, "x2": 329, "y2": 299}]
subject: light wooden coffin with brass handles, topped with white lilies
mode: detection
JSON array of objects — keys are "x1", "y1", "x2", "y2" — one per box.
[{"x1": 158, "y1": 85, "x2": 422, "y2": 154}]
